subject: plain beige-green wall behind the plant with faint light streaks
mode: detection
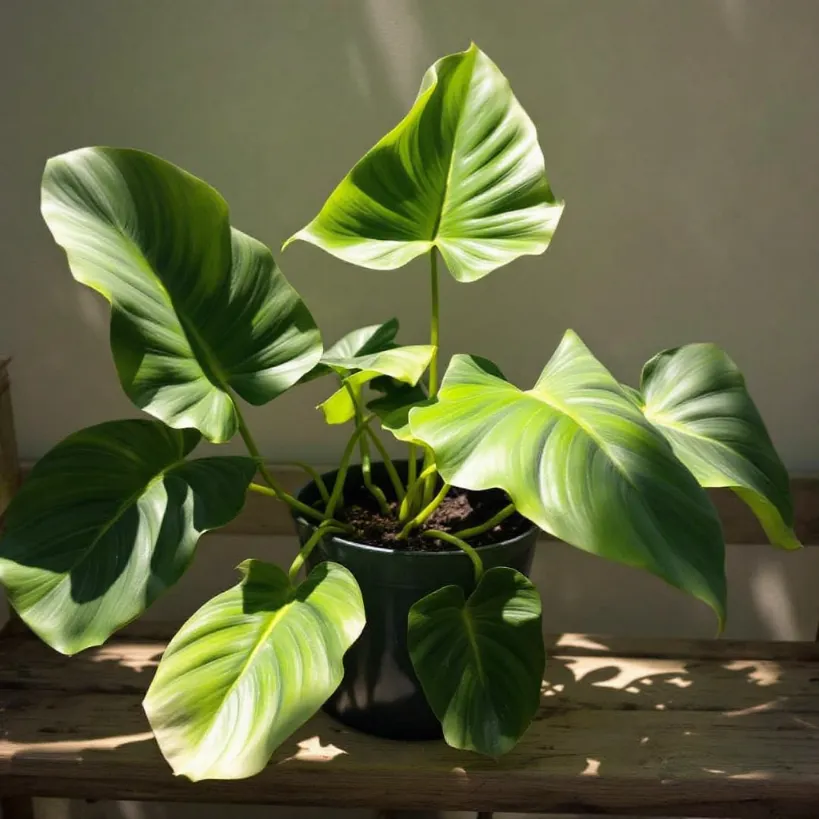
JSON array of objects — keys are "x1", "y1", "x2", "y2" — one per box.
[{"x1": 0, "y1": 0, "x2": 819, "y2": 819}]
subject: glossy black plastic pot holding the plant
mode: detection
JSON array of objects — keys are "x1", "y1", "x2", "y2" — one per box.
[{"x1": 296, "y1": 462, "x2": 538, "y2": 740}]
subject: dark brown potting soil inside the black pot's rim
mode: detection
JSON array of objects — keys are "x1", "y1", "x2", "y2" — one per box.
[{"x1": 336, "y1": 478, "x2": 531, "y2": 552}]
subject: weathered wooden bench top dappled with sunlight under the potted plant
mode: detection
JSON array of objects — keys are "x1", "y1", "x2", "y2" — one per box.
[{"x1": 0, "y1": 624, "x2": 819, "y2": 819}]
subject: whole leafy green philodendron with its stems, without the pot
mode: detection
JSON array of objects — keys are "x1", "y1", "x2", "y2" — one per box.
[{"x1": 0, "y1": 46, "x2": 799, "y2": 779}]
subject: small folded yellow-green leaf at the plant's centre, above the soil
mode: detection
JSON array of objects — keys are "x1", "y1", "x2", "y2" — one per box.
[{"x1": 319, "y1": 344, "x2": 435, "y2": 424}]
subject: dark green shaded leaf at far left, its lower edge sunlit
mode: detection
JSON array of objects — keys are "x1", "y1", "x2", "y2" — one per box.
[{"x1": 0, "y1": 420, "x2": 255, "y2": 654}]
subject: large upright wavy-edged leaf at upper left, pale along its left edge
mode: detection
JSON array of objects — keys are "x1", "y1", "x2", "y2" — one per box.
[{"x1": 42, "y1": 148, "x2": 321, "y2": 442}]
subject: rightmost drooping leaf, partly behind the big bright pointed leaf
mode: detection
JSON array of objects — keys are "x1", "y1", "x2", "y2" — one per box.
[{"x1": 641, "y1": 344, "x2": 801, "y2": 549}]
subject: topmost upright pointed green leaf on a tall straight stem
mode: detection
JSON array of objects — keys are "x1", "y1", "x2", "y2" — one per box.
[{"x1": 288, "y1": 45, "x2": 563, "y2": 282}]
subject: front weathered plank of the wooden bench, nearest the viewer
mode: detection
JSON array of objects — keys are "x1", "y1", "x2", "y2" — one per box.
[{"x1": 0, "y1": 692, "x2": 819, "y2": 816}]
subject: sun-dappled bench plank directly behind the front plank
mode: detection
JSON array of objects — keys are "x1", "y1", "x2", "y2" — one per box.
[{"x1": 0, "y1": 629, "x2": 819, "y2": 714}]
